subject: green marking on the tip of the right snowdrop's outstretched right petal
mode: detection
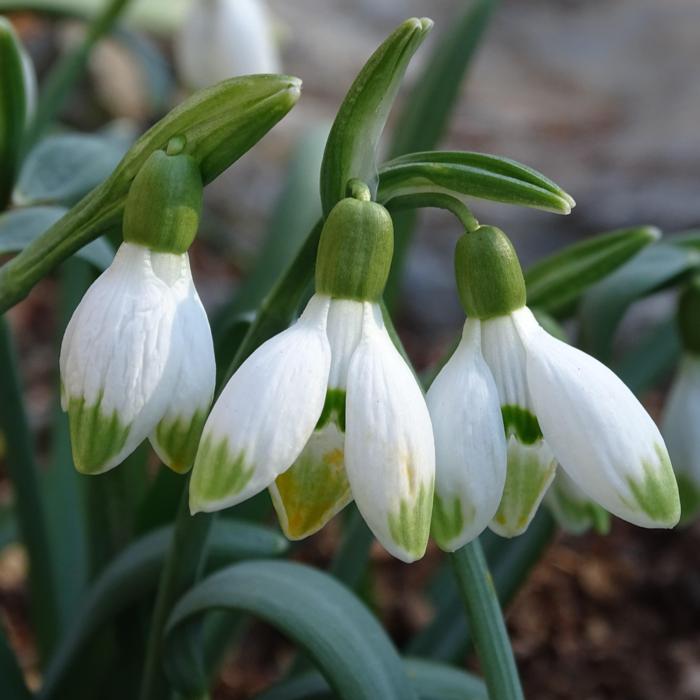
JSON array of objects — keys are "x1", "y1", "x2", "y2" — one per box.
[{"x1": 627, "y1": 445, "x2": 681, "y2": 527}]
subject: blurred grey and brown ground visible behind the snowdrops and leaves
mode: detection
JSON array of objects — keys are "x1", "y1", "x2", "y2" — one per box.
[{"x1": 0, "y1": 0, "x2": 700, "y2": 700}]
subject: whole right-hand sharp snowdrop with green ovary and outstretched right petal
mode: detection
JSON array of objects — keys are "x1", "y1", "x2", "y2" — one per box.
[{"x1": 428, "y1": 226, "x2": 679, "y2": 550}]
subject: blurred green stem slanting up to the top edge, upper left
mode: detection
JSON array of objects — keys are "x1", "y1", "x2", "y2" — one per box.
[{"x1": 24, "y1": 0, "x2": 130, "y2": 151}]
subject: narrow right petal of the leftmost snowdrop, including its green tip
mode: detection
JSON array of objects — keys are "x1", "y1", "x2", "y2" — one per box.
[{"x1": 150, "y1": 254, "x2": 216, "y2": 473}]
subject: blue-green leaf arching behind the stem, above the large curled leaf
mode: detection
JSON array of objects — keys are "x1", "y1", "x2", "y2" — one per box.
[{"x1": 41, "y1": 518, "x2": 288, "y2": 698}]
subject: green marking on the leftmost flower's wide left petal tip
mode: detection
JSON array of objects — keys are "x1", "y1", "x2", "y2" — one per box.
[{"x1": 68, "y1": 393, "x2": 131, "y2": 474}]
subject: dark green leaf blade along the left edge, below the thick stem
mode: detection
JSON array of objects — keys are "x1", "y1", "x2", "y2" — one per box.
[{"x1": 0, "y1": 318, "x2": 59, "y2": 658}]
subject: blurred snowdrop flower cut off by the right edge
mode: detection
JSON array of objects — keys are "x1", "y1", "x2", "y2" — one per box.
[{"x1": 661, "y1": 280, "x2": 700, "y2": 522}]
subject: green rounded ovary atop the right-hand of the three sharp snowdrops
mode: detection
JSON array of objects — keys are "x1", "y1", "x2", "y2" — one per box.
[{"x1": 455, "y1": 226, "x2": 526, "y2": 321}]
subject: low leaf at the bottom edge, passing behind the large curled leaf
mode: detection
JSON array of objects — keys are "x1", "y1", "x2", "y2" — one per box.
[{"x1": 254, "y1": 659, "x2": 488, "y2": 700}]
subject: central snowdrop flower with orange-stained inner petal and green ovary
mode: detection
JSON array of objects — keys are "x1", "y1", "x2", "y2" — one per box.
[{"x1": 190, "y1": 191, "x2": 435, "y2": 561}]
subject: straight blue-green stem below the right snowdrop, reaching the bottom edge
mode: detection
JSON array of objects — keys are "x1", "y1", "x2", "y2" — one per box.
[{"x1": 450, "y1": 540, "x2": 523, "y2": 700}]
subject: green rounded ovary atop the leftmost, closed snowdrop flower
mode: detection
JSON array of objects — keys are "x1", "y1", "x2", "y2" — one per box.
[{"x1": 124, "y1": 139, "x2": 203, "y2": 254}]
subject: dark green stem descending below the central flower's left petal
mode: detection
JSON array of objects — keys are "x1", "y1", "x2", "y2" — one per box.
[{"x1": 139, "y1": 488, "x2": 215, "y2": 700}]
